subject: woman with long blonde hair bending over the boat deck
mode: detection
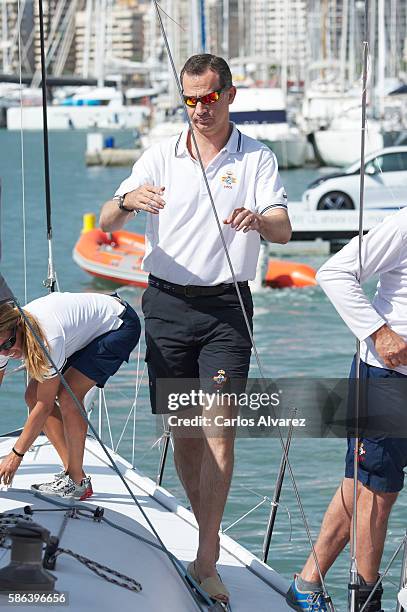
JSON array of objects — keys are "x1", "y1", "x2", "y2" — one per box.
[{"x1": 0, "y1": 293, "x2": 141, "y2": 499}]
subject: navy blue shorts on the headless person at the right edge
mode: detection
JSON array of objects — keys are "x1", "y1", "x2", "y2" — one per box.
[{"x1": 345, "y1": 358, "x2": 407, "y2": 493}]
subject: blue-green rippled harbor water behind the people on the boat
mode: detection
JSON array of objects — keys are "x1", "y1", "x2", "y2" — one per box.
[{"x1": 0, "y1": 131, "x2": 406, "y2": 612}]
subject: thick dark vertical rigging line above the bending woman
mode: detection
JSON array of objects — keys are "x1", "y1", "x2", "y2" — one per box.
[{"x1": 38, "y1": 0, "x2": 57, "y2": 293}]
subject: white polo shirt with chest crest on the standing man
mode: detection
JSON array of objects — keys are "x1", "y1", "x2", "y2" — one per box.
[{"x1": 115, "y1": 125, "x2": 287, "y2": 286}]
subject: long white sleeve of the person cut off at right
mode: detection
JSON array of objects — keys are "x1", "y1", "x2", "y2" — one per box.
[{"x1": 316, "y1": 214, "x2": 405, "y2": 341}]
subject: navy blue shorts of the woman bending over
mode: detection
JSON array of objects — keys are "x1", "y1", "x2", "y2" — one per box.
[{"x1": 62, "y1": 304, "x2": 141, "y2": 387}]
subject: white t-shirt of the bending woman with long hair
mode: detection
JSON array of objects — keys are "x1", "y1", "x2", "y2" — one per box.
[{"x1": 0, "y1": 293, "x2": 124, "y2": 378}]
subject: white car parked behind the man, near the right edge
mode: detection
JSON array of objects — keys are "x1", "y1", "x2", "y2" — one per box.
[{"x1": 302, "y1": 146, "x2": 407, "y2": 210}]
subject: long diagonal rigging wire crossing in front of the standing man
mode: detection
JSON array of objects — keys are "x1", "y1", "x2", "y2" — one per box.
[{"x1": 153, "y1": 0, "x2": 333, "y2": 609}]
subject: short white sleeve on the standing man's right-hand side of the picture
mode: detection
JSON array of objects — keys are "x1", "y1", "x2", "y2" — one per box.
[{"x1": 255, "y1": 147, "x2": 287, "y2": 215}]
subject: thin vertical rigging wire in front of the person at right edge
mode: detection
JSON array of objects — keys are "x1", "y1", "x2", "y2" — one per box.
[{"x1": 348, "y1": 0, "x2": 369, "y2": 612}]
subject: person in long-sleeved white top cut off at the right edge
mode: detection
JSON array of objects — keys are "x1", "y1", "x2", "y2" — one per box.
[{"x1": 287, "y1": 208, "x2": 407, "y2": 612}]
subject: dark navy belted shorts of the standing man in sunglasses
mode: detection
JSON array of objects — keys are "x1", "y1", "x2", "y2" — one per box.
[{"x1": 142, "y1": 286, "x2": 253, "y2": 414}]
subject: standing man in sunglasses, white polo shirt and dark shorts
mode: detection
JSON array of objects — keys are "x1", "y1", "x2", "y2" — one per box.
[{"x1": 100, "y1": 54, "x2": 291, "y2": 601}]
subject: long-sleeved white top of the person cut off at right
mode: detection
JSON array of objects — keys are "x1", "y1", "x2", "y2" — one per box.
[{"x1": 317, "y1": 208, "x2": 407, "y2": 374}]
